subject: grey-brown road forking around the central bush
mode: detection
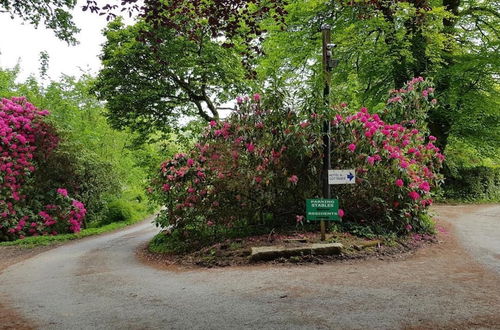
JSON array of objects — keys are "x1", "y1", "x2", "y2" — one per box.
[{"x1": 0, "y1": 205, "x2": 500, "y2": 329}]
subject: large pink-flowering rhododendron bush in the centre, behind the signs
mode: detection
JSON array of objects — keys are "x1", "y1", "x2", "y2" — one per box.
[{"x1": 151, "y1": 81, "x2": 443, "y2": 241}]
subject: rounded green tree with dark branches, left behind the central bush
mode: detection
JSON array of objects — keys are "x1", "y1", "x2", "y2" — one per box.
[{"x1": 95, "y1": 19, "x2": 249, "y2": 135}]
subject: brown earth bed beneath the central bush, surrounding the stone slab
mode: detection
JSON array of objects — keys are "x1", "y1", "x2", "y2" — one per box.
[{"x1": 137, "y1": 228, "x2": 437, "y2": 270}]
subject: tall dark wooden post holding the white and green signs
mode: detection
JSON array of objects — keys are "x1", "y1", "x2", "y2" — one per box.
[{"x1": 320, "y1": 24, "x2": 332, "y2": 241}]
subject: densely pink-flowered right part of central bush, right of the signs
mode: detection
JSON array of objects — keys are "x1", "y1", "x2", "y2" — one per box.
[{"x1": 332, "y1": 100, "x2": 444, "y2": 228}]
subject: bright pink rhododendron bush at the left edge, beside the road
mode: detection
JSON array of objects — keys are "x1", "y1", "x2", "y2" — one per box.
[{"x1": 0, "y1": 98, "x2": 86, "y2": 241}]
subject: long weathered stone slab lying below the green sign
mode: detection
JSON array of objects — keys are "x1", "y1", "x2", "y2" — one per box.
[{"x1": 250, "y1": 243, "x2": 343, "y2": 261}]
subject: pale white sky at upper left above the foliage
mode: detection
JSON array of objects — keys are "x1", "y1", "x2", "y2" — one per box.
[{"x1": 0, "y1": 0, "x2": 120, "y2": 80}]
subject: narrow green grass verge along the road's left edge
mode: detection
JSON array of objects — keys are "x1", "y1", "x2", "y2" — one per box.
[{"x1": 0, "y1": 213, "x2": 152, "y2": 248}]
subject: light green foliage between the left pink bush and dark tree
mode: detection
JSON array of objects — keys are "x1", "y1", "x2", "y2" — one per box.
[{"x1": 0, "y1": 65, "x2": 159, "y2": 226}]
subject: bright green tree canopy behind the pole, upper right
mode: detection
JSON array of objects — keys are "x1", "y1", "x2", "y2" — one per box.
[{"x1": 258, "y1": 0, "x2": 500, "y2": 157}]
